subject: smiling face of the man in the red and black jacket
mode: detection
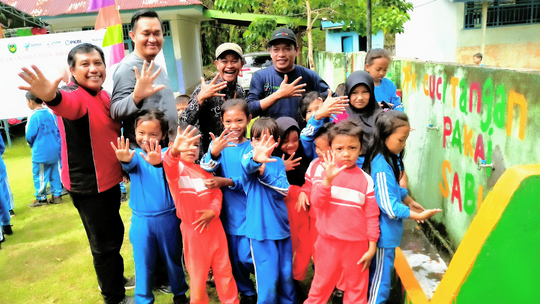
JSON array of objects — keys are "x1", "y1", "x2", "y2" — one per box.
[{"x1": 69, "y1": 50, "x2": 107, "y2": 91}]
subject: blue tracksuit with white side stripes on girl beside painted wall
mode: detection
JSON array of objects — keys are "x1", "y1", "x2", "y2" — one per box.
[{"x1": 368, "y1": 154, "x2": 411, "y2": 304}]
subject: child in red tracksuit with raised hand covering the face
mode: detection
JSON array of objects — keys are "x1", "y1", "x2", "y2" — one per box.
[{"x1": 158, "y1": 126, "x2": 239, "y2": 304}]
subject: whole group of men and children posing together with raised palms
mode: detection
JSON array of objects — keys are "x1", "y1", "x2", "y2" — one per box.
[{"x1": 9, "y1": 9, "x2": 440, "y2": 304}]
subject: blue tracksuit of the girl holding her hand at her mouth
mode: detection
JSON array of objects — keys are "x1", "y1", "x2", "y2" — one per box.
[{"x1": 201, "y1": 140, "x2": 256, "y2": 296}]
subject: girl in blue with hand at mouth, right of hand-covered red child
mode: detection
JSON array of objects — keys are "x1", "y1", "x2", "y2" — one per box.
[{"x1": 201, "y1": 99, "x2": 257, "y2": 303}]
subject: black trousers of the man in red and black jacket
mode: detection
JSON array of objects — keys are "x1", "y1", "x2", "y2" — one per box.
[{"x1": 70, "y1": 185, "x2": 125, "y2": 304}]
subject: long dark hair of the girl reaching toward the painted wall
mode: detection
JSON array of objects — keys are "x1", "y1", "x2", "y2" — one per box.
[{"x1": 362, "y1": 110, "x2": 409, "y2": 181}]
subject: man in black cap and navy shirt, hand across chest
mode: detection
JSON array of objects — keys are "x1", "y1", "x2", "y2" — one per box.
[{"x1": 247, "y1": 28, "x2": 329, "y2": 119}]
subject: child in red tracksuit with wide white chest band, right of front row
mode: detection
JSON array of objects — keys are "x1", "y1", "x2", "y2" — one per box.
[{"x1": 305, "y1": 121, "x2": 379, "y2": 304}]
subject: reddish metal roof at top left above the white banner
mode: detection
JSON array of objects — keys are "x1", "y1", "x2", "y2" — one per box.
[{"x1": 0, "y1": 0, "x2": 202, "y2": 16}]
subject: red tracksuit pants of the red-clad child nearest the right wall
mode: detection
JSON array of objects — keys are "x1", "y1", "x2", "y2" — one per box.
[{"x1": 304, "y1": 235, "x2": 369, "y2": 304}]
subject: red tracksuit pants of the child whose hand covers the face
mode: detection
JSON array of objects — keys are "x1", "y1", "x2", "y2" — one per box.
[{"x1": 180, "y1": 221, "x2": 239, "y2": 304}]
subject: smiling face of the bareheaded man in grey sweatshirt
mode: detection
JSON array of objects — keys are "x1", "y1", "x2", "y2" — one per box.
[{"x1": 129, "y1": 17, "x2": 163, "y2": 61}]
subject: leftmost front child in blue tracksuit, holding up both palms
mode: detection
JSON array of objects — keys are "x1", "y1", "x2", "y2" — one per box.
[{"x1": 111, "y1": 109, "x2": 188, "y2": 303}]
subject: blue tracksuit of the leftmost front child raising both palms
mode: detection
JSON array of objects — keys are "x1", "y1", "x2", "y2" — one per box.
[{"x1": 122, "y1": 148, "x2": 188, "y2": 304}]
